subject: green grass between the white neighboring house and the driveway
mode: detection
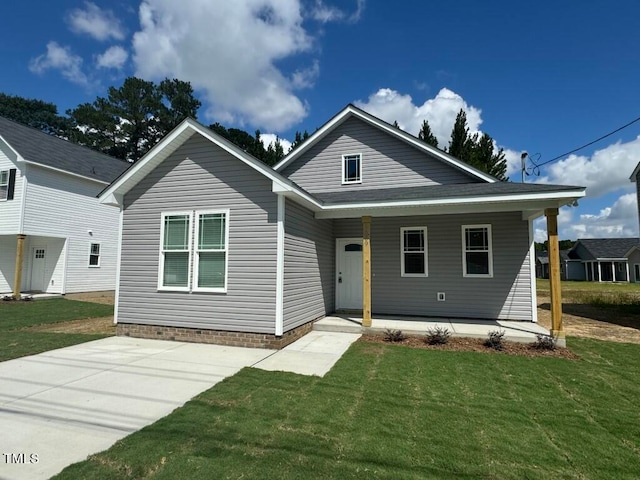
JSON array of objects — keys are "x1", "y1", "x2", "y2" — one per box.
[{"x1": 0, "y1": 298, "x2": 113, "y2": 361}]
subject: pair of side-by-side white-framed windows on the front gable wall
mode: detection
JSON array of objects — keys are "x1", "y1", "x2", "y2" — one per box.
[{"x1": 158, "y1": 210, "x2": 229, "y2": 292}]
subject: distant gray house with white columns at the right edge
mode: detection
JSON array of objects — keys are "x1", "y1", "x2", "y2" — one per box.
[{"x1": 567, "y1": 238, "x2": 640, "y2": 282}]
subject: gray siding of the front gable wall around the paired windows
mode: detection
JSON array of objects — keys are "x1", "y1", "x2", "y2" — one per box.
[{"x1": 118, "y1": 134, "x2": 277, "y2": 333}]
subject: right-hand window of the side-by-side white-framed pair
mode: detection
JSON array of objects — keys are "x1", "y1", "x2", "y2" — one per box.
[{"x1": 194, "y1": 212, "x2": 227, "y2": 291}]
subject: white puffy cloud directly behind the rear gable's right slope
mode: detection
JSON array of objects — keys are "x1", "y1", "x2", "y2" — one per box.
[{"x1": 355, "y1": 88, "x2": 482, "y2": 148}]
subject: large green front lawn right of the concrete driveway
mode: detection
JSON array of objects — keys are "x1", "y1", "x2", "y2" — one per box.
[{"x1": 56, "y1": 339, "x2": 640, "y2": 479}]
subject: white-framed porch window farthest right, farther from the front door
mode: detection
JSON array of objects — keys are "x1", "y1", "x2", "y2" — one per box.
[{"x1": 462, "y1": 225, "x2": 493, "y2": 277}]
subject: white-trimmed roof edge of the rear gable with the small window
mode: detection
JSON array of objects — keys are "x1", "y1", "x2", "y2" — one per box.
[{"x1": 273, "y1": 104, "x2": 499, "y2": 183}]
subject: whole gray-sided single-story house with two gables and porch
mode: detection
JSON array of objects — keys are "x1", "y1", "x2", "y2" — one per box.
[{"x1": 100, "y1": 105, "x2": 585, "y2": 347}]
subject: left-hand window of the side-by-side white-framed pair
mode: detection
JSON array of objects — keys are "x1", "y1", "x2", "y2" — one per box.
[{"x1": 158, "y1": 212, "x2": 193, "y2": 290}]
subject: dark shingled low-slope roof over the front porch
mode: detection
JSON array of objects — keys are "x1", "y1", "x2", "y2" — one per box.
[{"x1": 314, "y1": 182, "x2": 584, "y2": 205}]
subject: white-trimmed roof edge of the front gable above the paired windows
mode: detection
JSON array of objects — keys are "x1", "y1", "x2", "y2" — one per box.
[{"x1": 99, "y1": 118, "x2": 320, "y2": 208}]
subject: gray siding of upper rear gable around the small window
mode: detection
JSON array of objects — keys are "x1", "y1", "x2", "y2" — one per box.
[{"x1": 281, "y1": 118, "x2": 478, "y2": 193}]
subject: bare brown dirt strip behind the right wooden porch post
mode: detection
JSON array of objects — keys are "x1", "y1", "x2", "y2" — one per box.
[{"x1": 538, "y1": 296, "x2": 640, "y2": 344}]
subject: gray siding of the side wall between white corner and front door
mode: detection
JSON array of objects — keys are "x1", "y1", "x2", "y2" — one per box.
[{"x1": 284, "y1": 200, "x2": 335, "y2": 332}]
